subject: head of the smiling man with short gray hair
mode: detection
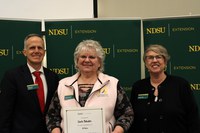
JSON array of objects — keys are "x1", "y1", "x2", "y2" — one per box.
[{"x1": 23, "y1": 36, "x2": 45, "y2": 68}]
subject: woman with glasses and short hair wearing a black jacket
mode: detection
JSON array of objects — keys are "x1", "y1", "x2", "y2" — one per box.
[{"x1": 129, "y1": 45, "x2": 200, "y2": 133}]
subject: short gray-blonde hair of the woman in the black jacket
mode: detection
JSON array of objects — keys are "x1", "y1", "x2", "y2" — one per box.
[{"x1": 143, "y1": 44, "x2": 170, "y2": 62}]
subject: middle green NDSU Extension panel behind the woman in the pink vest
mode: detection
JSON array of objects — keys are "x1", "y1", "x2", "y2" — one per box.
[{"x1": 45, "y1": 20, "x2": 141, "y2": 93}]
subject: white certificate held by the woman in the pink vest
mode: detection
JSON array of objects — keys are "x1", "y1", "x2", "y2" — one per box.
[{"x1": 64, "y1": 107, "x2": 106, "y2": 133}]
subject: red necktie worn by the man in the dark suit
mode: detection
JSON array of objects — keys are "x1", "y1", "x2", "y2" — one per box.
[{"x1": 33, "y1": 71, "x2": 45, "y2": 112}]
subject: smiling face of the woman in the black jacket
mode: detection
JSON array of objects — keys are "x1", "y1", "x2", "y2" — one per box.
[{"x1": 145, "y1": 51, "x2": 167, "y2": 74}]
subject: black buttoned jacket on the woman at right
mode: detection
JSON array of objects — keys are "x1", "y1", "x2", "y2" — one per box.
[{"x1": 129, "y1": 75, "x2": 200, "y2": 133}]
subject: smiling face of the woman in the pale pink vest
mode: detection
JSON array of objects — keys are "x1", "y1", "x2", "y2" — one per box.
[{"x1": 77, "y1": 49, "x2": 101, "y2": 74}]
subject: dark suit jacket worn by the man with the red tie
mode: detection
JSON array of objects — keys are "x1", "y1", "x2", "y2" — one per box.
[{"x1": 0, "y1": 65, "x2": 59, "y2": 133}]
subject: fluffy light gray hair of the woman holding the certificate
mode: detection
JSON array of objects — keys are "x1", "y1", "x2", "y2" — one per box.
[{"x1": 74, "y1": 40, "x2": 105, "y2": 72}]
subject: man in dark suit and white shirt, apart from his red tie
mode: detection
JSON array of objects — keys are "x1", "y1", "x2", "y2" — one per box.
[{"x1": 0, "y1": 34, "x2": 59, "y2": 133}]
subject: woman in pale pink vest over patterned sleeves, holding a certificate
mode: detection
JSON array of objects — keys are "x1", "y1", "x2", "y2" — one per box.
[{"x1": 46, "y1": 40, "x2": 133, "y2": 133}]
